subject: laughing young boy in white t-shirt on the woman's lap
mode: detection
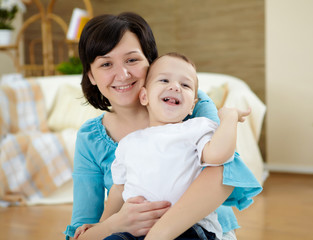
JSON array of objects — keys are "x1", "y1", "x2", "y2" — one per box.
[{"x1": 75, "y1": 53, "x2": 256, "y2": 239}]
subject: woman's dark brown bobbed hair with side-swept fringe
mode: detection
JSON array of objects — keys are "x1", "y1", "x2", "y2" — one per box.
[{"x1": 78, "y1": 12, "x2": 158, "y2": 111}]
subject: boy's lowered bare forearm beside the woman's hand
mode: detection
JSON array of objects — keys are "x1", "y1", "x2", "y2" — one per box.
[{"x1": 100, "y1": 184, "x2": 124, "y2": 221}]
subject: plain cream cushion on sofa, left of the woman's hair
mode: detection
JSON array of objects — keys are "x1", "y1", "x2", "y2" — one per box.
[{"x1": 48, "y1": 84, "x2": 102, "y2": 131}]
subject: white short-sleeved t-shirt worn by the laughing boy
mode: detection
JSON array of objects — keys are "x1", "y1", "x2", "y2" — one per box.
[{"x1": 111, "y1": 117, "x2": 233, "y2": 239}]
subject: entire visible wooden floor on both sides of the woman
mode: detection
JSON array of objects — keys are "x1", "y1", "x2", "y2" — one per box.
[{"x1": 0, "y1": 173, "x2": 313, "y2": 240}]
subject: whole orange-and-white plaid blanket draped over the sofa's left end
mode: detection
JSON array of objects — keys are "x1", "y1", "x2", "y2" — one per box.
[{"x1": 0, "y1": 80, "x2": 72, "y2": 205}]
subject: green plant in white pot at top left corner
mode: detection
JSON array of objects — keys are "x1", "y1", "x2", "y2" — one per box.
[{"x1": 0, "y1": 0, "x2": 25, "y2": 45}]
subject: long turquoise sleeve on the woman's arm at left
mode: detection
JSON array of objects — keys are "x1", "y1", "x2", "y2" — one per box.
[{"x1": 64, "y1": 116, "x2": 105, "y2": 239}]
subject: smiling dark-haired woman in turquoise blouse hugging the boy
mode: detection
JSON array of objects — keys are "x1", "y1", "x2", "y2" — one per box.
[{"x1": 65, "y1": 13, "x2": 260, "y2": 239}]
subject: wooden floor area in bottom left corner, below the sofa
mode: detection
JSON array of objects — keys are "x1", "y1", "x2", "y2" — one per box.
[{"x1": 0, "y1": 205, "x2": 72, "y2": 240}]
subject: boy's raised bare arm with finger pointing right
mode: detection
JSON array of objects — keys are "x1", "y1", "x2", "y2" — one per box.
[{"x1": 201, "y1": 107, "x2": 251, "y2": 164}]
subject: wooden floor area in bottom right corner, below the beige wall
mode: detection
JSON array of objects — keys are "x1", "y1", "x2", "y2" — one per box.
[{"x1": 235, "y1": 173, "x2": 313, "y2": 240}]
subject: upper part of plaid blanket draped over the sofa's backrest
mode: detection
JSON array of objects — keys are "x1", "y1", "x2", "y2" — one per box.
[{"x1": 0, "y1": 79, "x2": 48, "y2": 138}]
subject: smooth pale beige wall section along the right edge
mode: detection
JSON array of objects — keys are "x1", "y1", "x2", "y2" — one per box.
[{"x1": 266, "y1": 0, "x2": 313, "y2": 173}]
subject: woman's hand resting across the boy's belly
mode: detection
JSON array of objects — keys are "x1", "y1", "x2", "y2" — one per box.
[{"x1": 114, "y1": 196, "x2": 171, "y2": 236}]
